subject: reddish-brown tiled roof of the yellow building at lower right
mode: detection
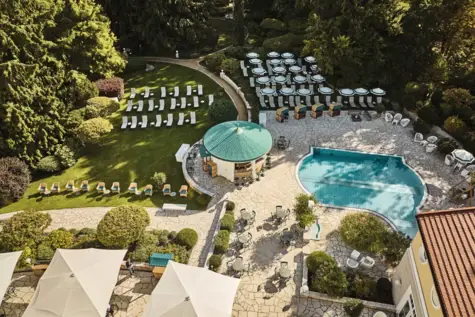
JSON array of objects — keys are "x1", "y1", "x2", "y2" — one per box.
[{"x1": 416, "y1": 208, "x2": 475, "y2": 317}]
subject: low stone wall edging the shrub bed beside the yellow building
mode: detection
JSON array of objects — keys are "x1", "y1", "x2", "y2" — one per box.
[{"x1": 300, "y1": 254, "x2": 396, "y2": 313}]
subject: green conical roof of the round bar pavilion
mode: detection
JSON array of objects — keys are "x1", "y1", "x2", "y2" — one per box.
[{"x1": 203, "y1": 121, "x2": 272, "y2": 162}]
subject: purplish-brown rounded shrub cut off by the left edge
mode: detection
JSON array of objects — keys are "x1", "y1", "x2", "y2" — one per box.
[{"x1": 0, "y1": 157, "x2": 31, "y2": 206}]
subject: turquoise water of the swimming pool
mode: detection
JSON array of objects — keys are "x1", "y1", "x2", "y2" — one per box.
[{"x1": 298, "y1": 148, "x2": 425, "y2": 237}]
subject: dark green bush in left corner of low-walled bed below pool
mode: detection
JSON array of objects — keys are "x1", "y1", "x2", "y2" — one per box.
[{"x1": 306, "y1": 251, "x2": 348, "y2": 297}]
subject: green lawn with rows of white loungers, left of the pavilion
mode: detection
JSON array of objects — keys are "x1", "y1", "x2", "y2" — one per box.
[{"x1": 0, "y1": 64, "x2": 227, "y2": 213}]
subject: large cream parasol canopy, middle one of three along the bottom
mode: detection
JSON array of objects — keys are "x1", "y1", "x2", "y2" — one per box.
[{"x1": 23, "y1": 249, "x2": 127, "y2": 317}]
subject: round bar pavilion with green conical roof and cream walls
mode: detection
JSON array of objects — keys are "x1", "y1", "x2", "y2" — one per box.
[{"x1": 203, "y1": 121, "x2": 272, "y2": 181}]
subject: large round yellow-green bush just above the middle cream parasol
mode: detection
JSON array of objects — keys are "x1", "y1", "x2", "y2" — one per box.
[{"x1": 97, "y1": 205, "x2": 150, "y2": 248}]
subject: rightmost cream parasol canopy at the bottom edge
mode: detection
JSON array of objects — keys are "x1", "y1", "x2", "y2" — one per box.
[{"x1": 144, "y1": 261, "x2": 240, "y2": 317}]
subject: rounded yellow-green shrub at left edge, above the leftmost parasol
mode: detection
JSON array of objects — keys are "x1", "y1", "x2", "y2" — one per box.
[{"x1": 0, "y1": 210, "x2": 51, "y2": 251}]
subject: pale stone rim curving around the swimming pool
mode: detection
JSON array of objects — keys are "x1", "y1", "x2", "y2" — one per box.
[{"x1": 295, "y1": 146, "x2": 428, "y2": 231}]
